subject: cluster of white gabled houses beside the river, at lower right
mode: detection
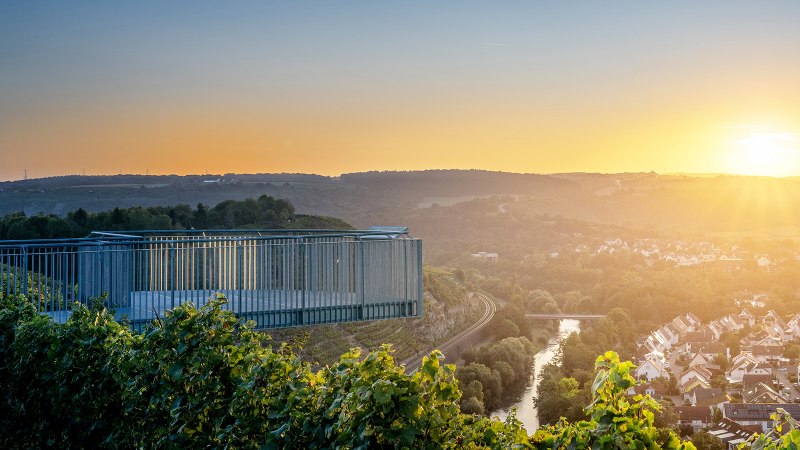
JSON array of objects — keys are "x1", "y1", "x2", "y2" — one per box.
[{"x1": 629, "y1": 296, "x2": 800, "y2": 448}]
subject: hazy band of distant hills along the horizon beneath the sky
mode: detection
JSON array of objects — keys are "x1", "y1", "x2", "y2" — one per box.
[{"x1": 0, "y1": 170, "x2": 800, "y2": 237}]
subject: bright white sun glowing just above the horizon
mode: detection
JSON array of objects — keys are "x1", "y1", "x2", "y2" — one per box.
[{"x1": 729, "y1": 133, "x2": 800, "y2": 177}]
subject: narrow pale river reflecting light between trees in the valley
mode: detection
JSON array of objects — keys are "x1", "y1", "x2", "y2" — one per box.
[{"x1": 491, "y1": 319, "x2": 581, "y2": 434}]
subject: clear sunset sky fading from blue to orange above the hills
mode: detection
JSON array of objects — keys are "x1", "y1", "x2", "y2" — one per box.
[{"x1": 0, "y1": 0, "x2": 800, "y2": 180}]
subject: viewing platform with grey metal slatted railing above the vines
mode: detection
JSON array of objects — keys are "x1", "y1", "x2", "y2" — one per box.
[{"x1": 0, "y1": 229, "x2": 423, "y2": 329}]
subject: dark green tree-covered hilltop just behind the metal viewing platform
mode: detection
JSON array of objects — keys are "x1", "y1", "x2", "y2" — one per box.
[{"x1": 0, "y1": 195, "x2": 352, "y2": 239}]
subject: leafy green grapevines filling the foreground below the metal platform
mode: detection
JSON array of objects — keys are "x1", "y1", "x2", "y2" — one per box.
[{"x1": 0, "y1": 290, "x2": 720, "y2": 449}]
